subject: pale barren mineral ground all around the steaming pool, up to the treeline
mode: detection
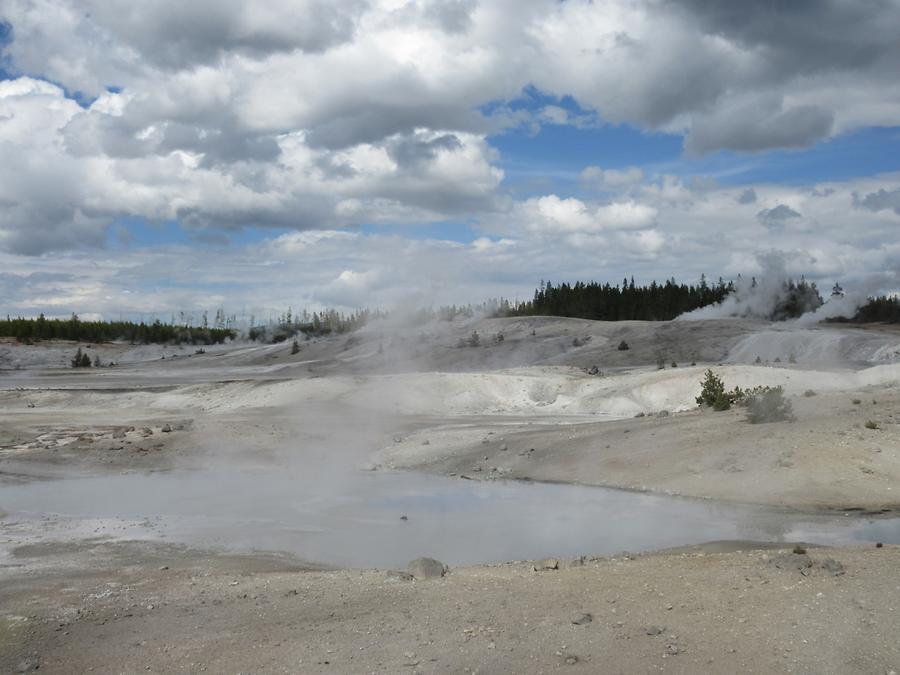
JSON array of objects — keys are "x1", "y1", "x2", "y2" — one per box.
[{"x1": 0, "y1": 318, "x2": 900, "y2": 673}]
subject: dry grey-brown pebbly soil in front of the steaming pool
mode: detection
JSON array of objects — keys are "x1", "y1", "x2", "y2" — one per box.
[{"x1": 0, "y1": 545, "x2": 900, "y2": 674}]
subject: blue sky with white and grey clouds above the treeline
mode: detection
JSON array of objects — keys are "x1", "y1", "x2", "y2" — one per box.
[{"x1": 0, "y1": 0, "x2": 900, "y2": 318}]
